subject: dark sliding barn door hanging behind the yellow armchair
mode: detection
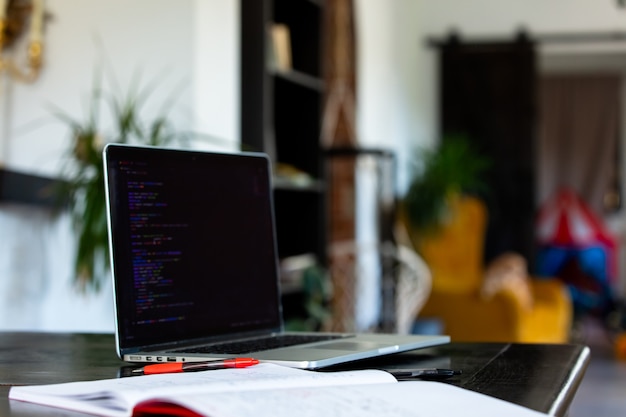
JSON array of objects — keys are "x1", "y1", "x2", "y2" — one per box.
[{"x1": 440, "y1": 39, "x2": 536, "y2": 264}]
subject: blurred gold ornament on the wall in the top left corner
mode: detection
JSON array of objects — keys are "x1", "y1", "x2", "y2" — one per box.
[{"x1": 0, "y1": 0, "x2": 45, "y2": 83}]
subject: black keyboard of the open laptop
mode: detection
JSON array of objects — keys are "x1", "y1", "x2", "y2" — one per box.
[{"x1": 171, "y1": 334, "x2": 346, "y2": 354}]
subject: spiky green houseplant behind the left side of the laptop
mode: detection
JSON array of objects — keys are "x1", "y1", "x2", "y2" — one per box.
[{"x1": 54, "y1": 73, "x2": 185, "y2": 291}]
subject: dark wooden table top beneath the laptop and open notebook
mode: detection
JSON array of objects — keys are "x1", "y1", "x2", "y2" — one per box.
[{"x1": 0, "y1": 332, "x2": 589, "y2": 416}]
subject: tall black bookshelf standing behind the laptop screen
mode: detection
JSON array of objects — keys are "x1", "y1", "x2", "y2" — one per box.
[{"x1": 241, "y1": 0, "x2": 327, "y2": 264}]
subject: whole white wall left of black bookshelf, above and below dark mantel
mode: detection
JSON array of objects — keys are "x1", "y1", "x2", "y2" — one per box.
[{"x1": 0, "y1": 0, "x2": 239, "y2": 331}]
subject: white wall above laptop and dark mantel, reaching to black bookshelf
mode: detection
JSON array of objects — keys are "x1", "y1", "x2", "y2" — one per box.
[{"x1": 0, "y1": 0, "x2": 239, "y2": 175}]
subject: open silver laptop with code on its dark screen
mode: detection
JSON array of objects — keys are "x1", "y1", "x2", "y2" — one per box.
[{"x1": 103, "y1": 144, "x2": 450, "y2": 369}]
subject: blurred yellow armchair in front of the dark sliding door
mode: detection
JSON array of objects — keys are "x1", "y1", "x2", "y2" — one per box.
[{"x1": 410, "y1": 196, "x2": 572, "y2": 343}]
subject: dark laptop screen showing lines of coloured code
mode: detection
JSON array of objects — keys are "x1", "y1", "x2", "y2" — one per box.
[{"x1": 105, "y1": 145, "x2": 281, "y2": 349}]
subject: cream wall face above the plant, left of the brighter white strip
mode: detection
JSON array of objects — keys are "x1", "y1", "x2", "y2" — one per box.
[{"x1": 1, "y1": 0, "x2": 188, "y2": 175}]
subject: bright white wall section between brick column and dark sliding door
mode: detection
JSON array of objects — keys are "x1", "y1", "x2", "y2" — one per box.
[{"x1": 355, "y1": 0, "x2": 424, "y2": 190}]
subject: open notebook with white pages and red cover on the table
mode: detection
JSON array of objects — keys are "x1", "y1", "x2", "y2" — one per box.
[{"x1": 9, "y1": 364, "x2": 545, "y2": 417}]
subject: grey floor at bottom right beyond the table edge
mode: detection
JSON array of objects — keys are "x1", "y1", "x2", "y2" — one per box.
[{"x1": 569, "y1": 321, "x2": 626, "y2": 417}]
